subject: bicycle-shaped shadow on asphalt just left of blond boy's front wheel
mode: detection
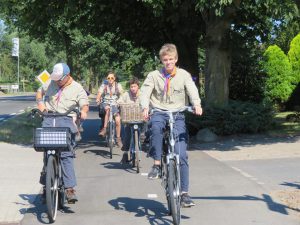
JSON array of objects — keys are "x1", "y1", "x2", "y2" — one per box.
[{"x1": 108, "y1": 197, "x2": 177, "y2": 225}]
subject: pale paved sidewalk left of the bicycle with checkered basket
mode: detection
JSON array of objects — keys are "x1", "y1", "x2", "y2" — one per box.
[{"x1": 0, "y1": 142, "x2": 42, "y2": 224}]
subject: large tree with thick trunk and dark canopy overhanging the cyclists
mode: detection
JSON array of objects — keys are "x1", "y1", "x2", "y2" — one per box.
[{"x1": 1, "y1": 0, "x2": 297, "y2": 105}]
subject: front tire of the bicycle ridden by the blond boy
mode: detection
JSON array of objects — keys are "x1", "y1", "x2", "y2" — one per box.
[{"x1": 167, "y1": 159, "x2": 181, "y2": 225}]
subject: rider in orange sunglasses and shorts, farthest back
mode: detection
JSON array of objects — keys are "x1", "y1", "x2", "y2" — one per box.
[{"x1": 96, "y1": 71, "x2": 123, "y2": 148}]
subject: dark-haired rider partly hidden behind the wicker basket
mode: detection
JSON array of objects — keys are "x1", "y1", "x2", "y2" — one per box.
[{"x1": 118, "y1": 77, "x2": 140, "y2": 163}]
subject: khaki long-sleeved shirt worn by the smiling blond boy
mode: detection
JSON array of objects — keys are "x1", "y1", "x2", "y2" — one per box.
[{"x1": 140, "y1": 68, "x2": 201, "y2": 110}]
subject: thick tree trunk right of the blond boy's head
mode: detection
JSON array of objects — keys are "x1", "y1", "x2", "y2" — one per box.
[{"x1": 205, "y1": 14, "x2": 231, "y2": 106}]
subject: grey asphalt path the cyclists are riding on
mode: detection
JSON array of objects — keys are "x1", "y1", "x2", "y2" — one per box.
[{"x1": 21, "y1": 103, "x2": 299, "y2": 225}]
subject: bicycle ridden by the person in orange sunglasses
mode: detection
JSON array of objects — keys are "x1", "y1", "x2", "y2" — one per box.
[{"x1": 103, "y1": 99, "x2": 117, "y2": 159}]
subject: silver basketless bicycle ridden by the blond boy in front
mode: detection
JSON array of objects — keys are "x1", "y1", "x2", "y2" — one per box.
[{"x1": 151, "y1": 106, "x2": 193, "y2": 225}]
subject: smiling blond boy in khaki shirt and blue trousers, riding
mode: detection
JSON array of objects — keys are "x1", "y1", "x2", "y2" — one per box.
[{"x1": 140, "y1": 44, "x2": 202, "y2": 207}]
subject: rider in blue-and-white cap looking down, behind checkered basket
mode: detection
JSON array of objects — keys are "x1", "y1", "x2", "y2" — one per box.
[{"x1": 36, "y1": 63, "x2": 89, "y2": 203}]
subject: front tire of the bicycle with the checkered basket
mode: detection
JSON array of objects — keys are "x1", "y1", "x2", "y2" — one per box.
[{"x1": 46, "y1": 155, "x2": 59, "y2": 223}]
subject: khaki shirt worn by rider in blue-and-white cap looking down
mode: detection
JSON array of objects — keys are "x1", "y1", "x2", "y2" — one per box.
[{"x1": 45, "y1": 80, "x2": 89, "y2": 113}]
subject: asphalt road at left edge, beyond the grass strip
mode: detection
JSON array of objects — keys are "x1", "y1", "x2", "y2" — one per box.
[{"x1": 0, "y1": 95, "x2": 35, "y2": 123}]
